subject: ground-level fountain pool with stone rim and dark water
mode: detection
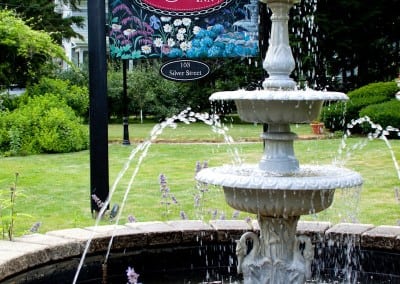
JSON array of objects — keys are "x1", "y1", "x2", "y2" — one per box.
[{"x1": 0, "y1": 220, "x2": 400, "y2": 284}]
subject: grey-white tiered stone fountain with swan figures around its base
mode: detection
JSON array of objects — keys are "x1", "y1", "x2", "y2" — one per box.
[{"x1": 196, "y1": 0, "x2": 362, "y2": 284}]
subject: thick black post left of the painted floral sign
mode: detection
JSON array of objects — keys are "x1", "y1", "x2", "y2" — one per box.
[{"x1": 87, "y1": 0, "x2": 109, "y2": 215}]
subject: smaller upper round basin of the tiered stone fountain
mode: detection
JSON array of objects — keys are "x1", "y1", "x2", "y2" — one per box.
[{"x1": 210, "y1": 90, "x2": 348, "y2": 123}]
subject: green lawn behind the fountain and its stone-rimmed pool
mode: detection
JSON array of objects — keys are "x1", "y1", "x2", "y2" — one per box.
[{"x1": 0, "y1": 123, "x2": 400, "y2": 234}]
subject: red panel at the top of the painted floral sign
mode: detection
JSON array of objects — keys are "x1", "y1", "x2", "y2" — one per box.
[{"x1": 142, "y1": 0, "x2": 226, "y2": 12}]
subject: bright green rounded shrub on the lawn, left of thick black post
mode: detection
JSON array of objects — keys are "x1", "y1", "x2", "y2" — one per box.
[{"x1": 0, "y1": 95, "x2": 88, "y2": 155}]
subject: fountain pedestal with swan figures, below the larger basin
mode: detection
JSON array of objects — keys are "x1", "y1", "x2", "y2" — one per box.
[{"x1": 236, "y1": 216, "x2": 314, "y2": 284}]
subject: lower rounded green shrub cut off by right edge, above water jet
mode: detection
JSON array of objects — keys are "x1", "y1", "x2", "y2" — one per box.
[{"x1": 360, "y1": 99, "x2": 400, "y2": 133}]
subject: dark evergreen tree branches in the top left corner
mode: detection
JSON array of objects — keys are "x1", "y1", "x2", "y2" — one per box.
[{"x1": 0, "y1": 0, "x2": 84, "y2": 43}]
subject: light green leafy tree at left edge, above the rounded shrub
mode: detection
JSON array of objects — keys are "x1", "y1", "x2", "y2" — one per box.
[{"x1": 0, "y1": 10, "x2": 68, "y2": 86}]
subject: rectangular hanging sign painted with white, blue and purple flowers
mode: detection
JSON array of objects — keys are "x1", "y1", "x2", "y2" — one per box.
[{"x1": 108, "y1": 0, "x2": 258, "y2": 59}]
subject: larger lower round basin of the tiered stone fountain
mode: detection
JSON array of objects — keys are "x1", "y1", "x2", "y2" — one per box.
[{"x1": 196, "y1": 165, "x2": 362, "y2": 217}]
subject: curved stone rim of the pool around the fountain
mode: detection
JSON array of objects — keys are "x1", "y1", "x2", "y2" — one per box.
[{"x1": 0, "y1": 220, "x2": 400, "y2": 282}]
